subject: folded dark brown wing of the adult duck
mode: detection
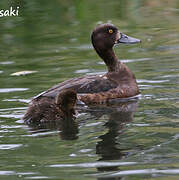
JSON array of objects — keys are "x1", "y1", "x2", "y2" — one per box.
[{"x1": 33, "y1": 75, "x2": 117, "y2": 99}]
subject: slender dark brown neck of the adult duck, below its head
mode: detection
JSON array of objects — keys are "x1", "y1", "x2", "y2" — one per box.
[{"x1": 96, "y1": 48, "x2": 120, "y2": 72}]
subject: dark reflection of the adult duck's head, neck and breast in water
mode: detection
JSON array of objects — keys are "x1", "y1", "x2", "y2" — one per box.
[{"x1": 89, "y1": 101, "x2": 137, "y2": 180}]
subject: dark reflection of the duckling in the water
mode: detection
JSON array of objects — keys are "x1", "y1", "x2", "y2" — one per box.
[{"x1": 25, "y1": 118, "x2": 78, "y2": 140}]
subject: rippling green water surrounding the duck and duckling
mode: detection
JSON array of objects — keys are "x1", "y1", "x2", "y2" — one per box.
[{"x1": 0, "y1": 0, "x2": 179, "y2": 180}]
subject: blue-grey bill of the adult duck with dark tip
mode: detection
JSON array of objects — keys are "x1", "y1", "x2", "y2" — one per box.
[{"x1": 115, "y1": 32, "x2": 141, "y2": 44}]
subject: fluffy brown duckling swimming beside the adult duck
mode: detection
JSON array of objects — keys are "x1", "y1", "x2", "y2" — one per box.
[{"x1": 23, "y1": 89, "x2": 77, "y2": 125}]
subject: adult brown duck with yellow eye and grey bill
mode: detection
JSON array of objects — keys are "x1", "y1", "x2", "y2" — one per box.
[{"x1": 32, "y1": 23, "x2": 141, "y2": 104}]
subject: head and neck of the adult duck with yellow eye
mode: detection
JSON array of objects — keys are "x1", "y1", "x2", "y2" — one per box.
[{"x1": 91, "y1": 23, "x2": 141, "y2": 72}]
